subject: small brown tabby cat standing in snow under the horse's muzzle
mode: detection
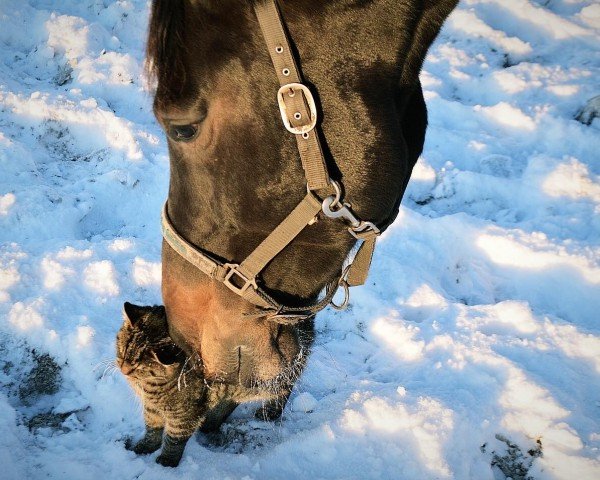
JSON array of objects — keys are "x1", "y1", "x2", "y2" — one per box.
[{"x1": 117, "y1": 302, "x2": 298, "y2": 467}]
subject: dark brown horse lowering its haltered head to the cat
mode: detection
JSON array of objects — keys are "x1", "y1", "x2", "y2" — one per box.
[{"x1": 148, "y1": 0, "x2": 457, "y2": 428}]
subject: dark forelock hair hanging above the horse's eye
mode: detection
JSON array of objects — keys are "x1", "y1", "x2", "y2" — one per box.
[{"x1": 146, "y1": 0, "x2": 189, "y2": 98}]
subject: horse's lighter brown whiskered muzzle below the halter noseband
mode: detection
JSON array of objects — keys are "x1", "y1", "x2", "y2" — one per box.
[{"x1": 162, "y1": 245, "x2": 312, "y2": 401}]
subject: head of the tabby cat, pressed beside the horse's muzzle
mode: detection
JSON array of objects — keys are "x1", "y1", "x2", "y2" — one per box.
[{"x1": 117, "y1": 302, "x2": 185, "y2": 379}]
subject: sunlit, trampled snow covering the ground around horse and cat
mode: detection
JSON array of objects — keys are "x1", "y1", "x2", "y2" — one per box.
[{"x1": 0, "y1": 0, "x2": 600, "y2": 480}]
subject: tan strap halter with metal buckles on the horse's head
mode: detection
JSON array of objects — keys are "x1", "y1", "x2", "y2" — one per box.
[{"x1": 162, "y1": 0, "x2": 380, "y2": 323}]
